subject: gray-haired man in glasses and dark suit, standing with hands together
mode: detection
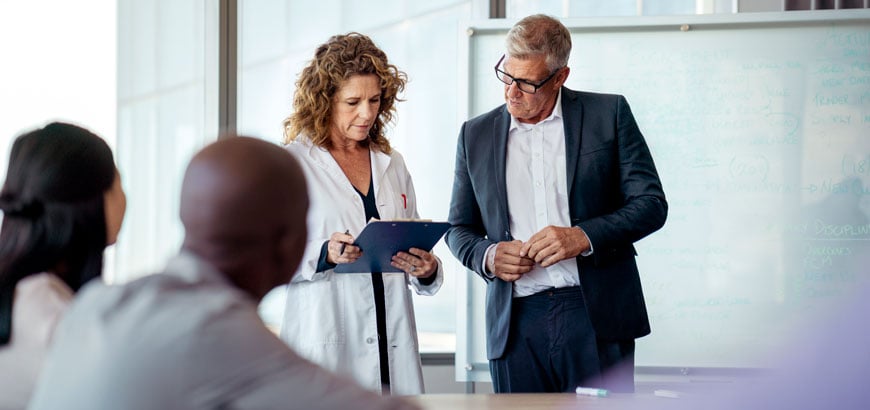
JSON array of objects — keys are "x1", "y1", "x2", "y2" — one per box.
[{"x1": 446, "y1": 15, "x2": 667, "y2": 393}]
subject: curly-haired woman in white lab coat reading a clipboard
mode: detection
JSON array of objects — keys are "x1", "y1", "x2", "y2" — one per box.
[{"x1": 281, "y1": 33, "x2": 444, "y2": 394}]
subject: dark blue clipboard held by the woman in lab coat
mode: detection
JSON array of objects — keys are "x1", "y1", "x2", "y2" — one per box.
[{"x1": 335, "y1": 221, "x2": 450, "y2": 273}]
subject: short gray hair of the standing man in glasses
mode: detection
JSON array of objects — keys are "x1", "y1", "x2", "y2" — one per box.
[{"x1": 505, "y1": 14, "x2": 571, "y2": 72}]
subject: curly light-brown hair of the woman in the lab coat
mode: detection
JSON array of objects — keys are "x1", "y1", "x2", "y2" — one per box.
[{"x1": 284, "y1": 32, "x2": 408, "y2": 154}]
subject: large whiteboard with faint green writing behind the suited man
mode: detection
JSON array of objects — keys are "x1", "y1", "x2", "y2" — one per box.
[{"x1": 457, "y1": 10, "x2": 870, "y2": 380}]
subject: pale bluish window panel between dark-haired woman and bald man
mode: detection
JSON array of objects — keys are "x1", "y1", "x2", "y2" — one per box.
[{"x1": 116, "y1": 0, "x2": 218, "y2": 280}]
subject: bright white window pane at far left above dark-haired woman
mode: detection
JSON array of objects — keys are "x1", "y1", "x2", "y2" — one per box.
[{"x1": 0, "y1": 0, "x2": 117, "y2": 276}]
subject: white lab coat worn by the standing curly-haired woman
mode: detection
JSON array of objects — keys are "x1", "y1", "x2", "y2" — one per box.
[{"x1": 281, "y1": 138, "x2": 444, "y2": 394}]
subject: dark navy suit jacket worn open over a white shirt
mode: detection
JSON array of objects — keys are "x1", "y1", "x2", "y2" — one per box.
[{"x1": 445, "y1": 87, "x2": 667, "y2": 360}]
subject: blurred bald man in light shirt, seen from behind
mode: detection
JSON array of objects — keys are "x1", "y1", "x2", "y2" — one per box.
[{"x1": 31, "y1": 137, "x2": 413, "y2": 409}]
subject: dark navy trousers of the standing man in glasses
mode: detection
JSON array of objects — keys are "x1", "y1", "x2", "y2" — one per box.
[{"x1": 489, "y1": 287, "x2": 634, "y2": 393}]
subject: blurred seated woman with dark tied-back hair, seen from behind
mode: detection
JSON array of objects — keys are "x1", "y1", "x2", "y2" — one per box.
[{"x1": 0, "y1": 123, "x2": 126, "y2": 409}]
